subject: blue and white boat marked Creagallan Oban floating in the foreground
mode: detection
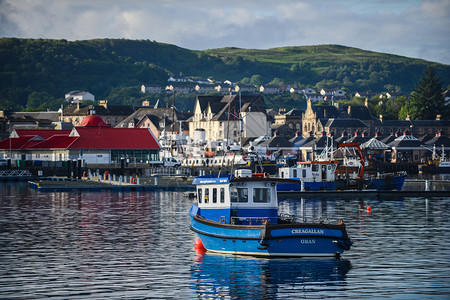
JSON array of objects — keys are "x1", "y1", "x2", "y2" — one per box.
[{"x1": 189, "y1": 170, "x2": 352, "y2": 257}]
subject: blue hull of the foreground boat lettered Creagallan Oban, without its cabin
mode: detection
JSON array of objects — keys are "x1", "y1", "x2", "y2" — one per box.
[{"x1": 191, "y1": 216, "x2": 351, "y2": 257}]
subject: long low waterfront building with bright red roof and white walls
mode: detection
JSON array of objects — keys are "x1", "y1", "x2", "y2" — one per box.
[{"x1": 0, "y1": 115, "x2": 160, "y2": 164}]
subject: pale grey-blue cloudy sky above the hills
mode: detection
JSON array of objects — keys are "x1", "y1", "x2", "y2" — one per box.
[{"x1": 0, "y1": 0, "x2": 450, "y2": 64}]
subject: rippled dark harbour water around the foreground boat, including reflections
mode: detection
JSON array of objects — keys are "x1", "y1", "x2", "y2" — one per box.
[{"x1": 0, "y1": 182, "x2": 450, "y2": 299}]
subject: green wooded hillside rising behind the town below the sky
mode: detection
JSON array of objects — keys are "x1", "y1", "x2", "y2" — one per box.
[{"x1": 0, "y1": 38, "x2": 450, "y2": 115}]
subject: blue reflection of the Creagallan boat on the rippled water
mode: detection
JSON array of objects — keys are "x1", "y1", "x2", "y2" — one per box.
[{"x1": 191, "y1": 253, "x2": 351, "y2": 299}]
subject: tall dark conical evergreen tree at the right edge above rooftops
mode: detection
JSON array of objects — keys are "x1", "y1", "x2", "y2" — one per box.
[{"x1": 407, "y1": 67, "x2": 448, "y2": 120}]
